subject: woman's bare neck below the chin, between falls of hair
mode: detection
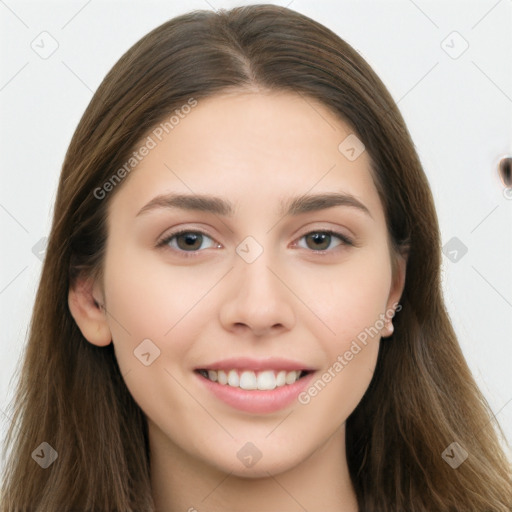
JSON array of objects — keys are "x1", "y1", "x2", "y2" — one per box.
[{"x1": 149, "y1": 422, "x2": 358, "y2": 512}]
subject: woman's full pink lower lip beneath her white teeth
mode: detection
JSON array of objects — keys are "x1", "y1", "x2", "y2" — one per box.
[{"x1": 196, "y1": 372, "x2": 314, "y2": 414}]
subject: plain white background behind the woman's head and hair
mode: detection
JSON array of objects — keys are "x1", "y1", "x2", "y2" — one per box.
[{"x1": 0, "y1": 0, "x2": 512, "y2": 472}]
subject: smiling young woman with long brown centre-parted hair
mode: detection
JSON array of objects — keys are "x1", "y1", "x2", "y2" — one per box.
[{"x1": 1, "y1": 6, "x2": 512, "y2": 512}]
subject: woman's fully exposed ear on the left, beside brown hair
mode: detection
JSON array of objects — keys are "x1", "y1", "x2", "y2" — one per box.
[{"x1": 68, "y1": 278, "x2": 112, "y2": 347}]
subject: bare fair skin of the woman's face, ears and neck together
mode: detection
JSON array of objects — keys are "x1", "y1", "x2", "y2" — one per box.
[{"x1": 69, "y1": 91, "x2": 405, "y2": 512}]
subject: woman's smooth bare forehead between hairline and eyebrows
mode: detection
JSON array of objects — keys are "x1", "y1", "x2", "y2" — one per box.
[{"x1": 109, "y1": 92, "x2": 380, "y2": 224}]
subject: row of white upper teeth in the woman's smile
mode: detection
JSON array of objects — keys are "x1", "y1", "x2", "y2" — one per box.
[{"x1": 202, "y1": 370, "x2": 301, "y2": 391}]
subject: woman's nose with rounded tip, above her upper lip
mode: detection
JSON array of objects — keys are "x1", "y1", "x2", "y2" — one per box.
[{"x1": 220, "y1": 253, "x2": 296, "y2": 337}]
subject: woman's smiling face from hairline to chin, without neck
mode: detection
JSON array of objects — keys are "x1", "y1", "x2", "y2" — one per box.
[{"x1": 87, "y1": 93, "x2": 403, "y2": 476}]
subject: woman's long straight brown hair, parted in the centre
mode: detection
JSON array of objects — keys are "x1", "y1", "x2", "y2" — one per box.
[{"x1": 0, "y1": 5, "x2": 512, "y2": 512}]
